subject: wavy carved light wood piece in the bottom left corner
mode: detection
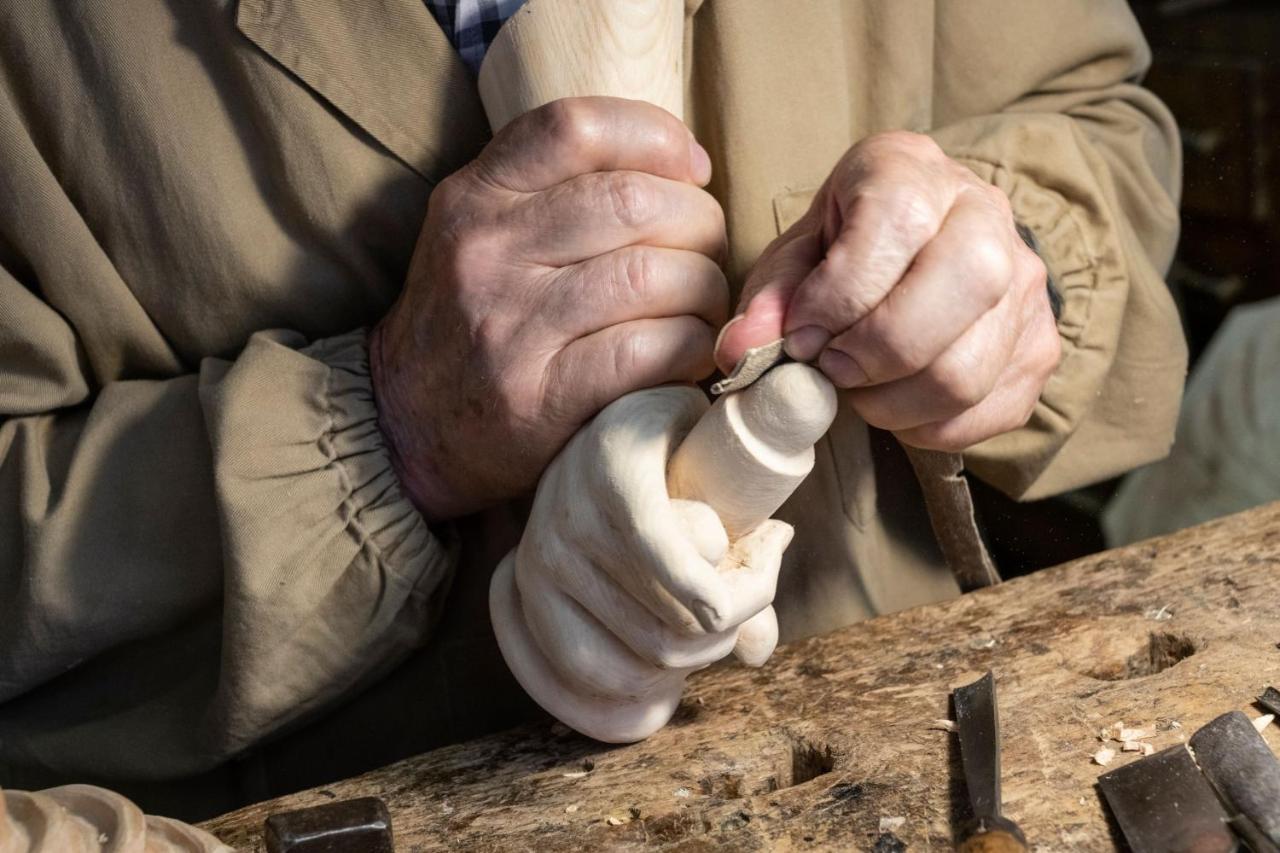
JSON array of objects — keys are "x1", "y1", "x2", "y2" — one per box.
[{"x1": 0, "y1": 785, "x2": 234, "y2": 853}]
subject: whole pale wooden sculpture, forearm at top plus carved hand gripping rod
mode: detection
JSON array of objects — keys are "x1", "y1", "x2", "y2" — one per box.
[{"x1": 479, "y1": 0, "x2": 836, "y2": 742}]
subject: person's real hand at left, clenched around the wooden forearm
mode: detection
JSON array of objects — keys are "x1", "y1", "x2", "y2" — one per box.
[{"x1": 370, "y1": 97, "x2": 728, "y2": 520}]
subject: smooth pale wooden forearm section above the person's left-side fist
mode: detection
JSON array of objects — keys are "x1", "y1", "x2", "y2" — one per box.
[{"x1": 480, "y1": 0, "x2": 685, "y2": 131}]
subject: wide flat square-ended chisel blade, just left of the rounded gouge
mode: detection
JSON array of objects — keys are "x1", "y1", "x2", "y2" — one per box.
[{"x1": 1098, "y1": 744, "x2": 1239, "y2": 853}]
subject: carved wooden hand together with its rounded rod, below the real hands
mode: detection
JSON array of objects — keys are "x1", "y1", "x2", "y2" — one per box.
[{"x1": 490, "y1": 364, "x2": 836, "y2": 743}]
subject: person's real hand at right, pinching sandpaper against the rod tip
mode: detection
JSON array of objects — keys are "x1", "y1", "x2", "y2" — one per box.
[{"x1": 716, "y1": 132, "x2": 1060, "y2": 451}]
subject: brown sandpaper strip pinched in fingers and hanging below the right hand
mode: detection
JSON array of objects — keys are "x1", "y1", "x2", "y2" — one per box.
[{"x1": 712, "y1": 338, "x2": 1000, "y2": 592}]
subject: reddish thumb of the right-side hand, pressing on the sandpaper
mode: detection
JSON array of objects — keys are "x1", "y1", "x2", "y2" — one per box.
[{"x1": 716, "y1": 211, "x2": 822, "y2": 374}]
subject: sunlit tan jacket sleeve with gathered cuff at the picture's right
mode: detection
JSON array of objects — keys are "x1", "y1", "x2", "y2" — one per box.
[{"x1": 931, "y1": 0, "x2": 1187, "y2": 500}]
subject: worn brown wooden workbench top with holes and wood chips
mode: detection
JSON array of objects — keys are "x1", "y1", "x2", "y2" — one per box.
[{"x1": 205, "y1": 503, "x2": 1280, "y2": 853}]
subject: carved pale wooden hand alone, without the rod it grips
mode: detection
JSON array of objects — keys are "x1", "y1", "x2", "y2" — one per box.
[{"x1": 490, "y1": 387, "x2": 791, "y2": 742}]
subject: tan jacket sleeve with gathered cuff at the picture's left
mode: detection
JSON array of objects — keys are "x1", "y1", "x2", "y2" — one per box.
[{"x1": 0, "y1": 83, "x2": 453, "y2": 779}]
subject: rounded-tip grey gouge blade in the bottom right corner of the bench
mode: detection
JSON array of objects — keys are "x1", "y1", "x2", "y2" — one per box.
[{"x1": 1190, "y1": 711, "x2": 1280, "y2": 853}]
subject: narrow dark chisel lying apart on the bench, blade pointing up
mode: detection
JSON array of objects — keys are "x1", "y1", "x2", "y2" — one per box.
[{"x1": 951, "y1": 670, "x2": 1027, "y2": 853}]
